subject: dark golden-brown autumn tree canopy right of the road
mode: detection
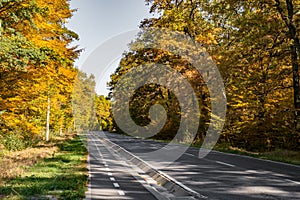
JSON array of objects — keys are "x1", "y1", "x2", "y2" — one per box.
[{"x1": 110, "y1": 0, "x2": 300, "y2": 150}]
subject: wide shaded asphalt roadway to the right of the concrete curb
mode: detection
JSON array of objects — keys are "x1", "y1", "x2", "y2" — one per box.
[{"x1": 96, "y1": 132, "x2": 300, "y2": 200}]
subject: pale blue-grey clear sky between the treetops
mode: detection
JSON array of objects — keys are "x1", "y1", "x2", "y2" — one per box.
[{"x1": 67, "y1": 0, "x2": 151, "y2": 95}]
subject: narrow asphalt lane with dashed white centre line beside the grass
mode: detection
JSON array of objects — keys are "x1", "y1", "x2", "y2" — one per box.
[{"x1": 86, "y1": 134, "x2": 156, "y2": 200}]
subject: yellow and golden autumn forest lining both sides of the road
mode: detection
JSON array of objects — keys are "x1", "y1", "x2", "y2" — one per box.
[{"x1": 0, "y1": 0, "x2": 300, "y2": 151}]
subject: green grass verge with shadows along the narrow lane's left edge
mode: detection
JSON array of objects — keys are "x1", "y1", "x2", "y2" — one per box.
[{"x1": 0, "y1": 135, "x2": 87, "y2": 200}]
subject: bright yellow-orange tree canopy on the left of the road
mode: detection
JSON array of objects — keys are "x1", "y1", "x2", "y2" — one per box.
[{"x1": 0, "y1": 0, "x2": 80, "y2": 148}]
